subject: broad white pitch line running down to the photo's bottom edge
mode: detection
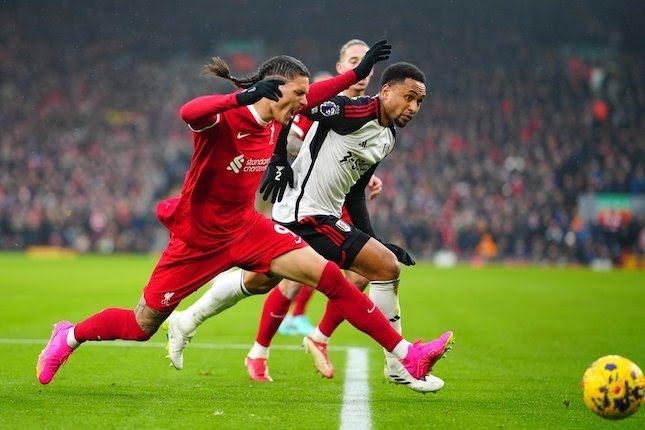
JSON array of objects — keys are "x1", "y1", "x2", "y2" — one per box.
[{"x1": 340, "y1": 348, "x2": 372, "y2": 430}]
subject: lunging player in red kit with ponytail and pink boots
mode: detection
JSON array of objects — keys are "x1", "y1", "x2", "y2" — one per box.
[{"x1": 36, "y1": 41, "x2": 448, "y2": 390}]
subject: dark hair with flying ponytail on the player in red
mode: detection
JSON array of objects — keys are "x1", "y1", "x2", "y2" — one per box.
[{"x1": 202, "y1": 55, "x2": 310, "y2": 88}]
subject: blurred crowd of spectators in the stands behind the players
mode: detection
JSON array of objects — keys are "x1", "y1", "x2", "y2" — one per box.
[{"x1": 0, "y1": 2, "x2": 645, "y2": 264}]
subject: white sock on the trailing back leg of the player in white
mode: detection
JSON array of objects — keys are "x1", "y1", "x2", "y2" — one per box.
[{"x1": 177, "y1": 270, "x2": 251, "y2": 333}]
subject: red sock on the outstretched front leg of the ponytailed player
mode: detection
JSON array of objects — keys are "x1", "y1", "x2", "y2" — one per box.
[{"x1": 317, "y1": 262, "x2": 403, "y2": 351}]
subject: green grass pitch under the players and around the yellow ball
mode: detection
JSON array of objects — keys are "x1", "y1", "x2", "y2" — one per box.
[{"x1": 0, "y1": 254, "x2": 645, "y2": 430}]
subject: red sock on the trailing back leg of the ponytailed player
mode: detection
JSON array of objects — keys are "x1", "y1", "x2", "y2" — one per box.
[{"x1": 74, "y1": 308, "x2": 150, "y2": 342}]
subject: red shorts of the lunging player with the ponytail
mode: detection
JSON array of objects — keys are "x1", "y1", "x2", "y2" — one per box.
[{"x1": 143, "y1": 214, "x2": 307, "y2": 312}]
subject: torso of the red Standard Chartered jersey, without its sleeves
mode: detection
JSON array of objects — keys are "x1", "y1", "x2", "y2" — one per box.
[{"x1": 160, "y1": 106, "x2": 281, "y2": 247}]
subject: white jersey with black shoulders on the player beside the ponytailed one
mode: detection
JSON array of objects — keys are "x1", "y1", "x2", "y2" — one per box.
[{"x1": 272, "y1": 96, "x2": 395, "y2": 224}]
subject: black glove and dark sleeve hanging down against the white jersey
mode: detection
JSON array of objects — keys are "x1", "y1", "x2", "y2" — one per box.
[{"x1": 260, "y1": 120, "x2": 293, "y2": 203}]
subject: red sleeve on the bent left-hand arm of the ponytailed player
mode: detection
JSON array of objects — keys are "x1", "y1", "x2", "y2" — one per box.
[{"x1": 179, "y1": 94, "x2": 239, "y2": 132}]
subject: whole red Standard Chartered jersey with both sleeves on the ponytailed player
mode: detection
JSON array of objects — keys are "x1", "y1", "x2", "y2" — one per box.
[{"x1": 157, "y1": 70, "x2": 356, "y2": 248}]
